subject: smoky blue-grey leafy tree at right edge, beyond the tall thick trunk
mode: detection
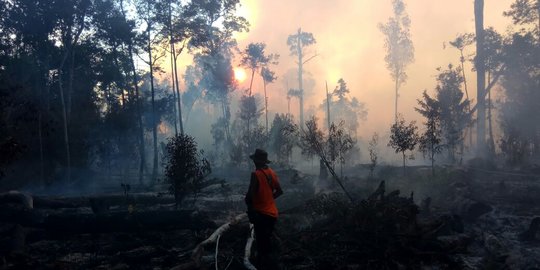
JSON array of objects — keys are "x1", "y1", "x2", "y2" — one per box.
[{"x1": 499, "y1": 33, "x2": 540, "y2": 165}]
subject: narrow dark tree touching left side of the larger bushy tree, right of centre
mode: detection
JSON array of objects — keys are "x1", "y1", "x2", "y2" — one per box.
[{"x1": 415, "y1": 91, "x2": 443, "y2": 176}]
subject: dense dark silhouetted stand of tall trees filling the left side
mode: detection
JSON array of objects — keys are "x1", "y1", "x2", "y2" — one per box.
[{"x1": 0, "y1": 0, "x2": 248, "y2": 186}]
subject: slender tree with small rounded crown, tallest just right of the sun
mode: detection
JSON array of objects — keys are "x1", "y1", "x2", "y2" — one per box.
[{"x1": 287, "y1": 28, "x2": 317, "y2": 129}]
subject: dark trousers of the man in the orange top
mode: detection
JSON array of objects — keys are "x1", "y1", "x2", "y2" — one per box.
[{"x1": 252, "y1": 213, "x2": 277, "y2": 269}]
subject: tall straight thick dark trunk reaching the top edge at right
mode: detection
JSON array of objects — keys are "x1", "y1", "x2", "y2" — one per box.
[{"x1": 474, "y1": 0, "x2": 486, "y2": 157}]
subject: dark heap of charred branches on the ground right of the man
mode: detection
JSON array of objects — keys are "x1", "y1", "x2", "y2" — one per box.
[{"x1": 279, "y1": 181, "x2": 471, "y2": 269}]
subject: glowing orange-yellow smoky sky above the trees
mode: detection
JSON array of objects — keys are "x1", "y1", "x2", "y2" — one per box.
[{"x1": 231, "y1": 0, "x2": 513, "y2": 139}]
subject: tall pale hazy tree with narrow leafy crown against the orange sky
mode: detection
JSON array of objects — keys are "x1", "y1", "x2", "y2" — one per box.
[{"x1": 379, "y1": 0, "x2": 414, "y2": 122}]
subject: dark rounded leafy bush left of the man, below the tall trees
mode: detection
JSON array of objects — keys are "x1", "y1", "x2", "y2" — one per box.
[{"x1": 165, "y1": 134, "x2": 211, "y2": 206}]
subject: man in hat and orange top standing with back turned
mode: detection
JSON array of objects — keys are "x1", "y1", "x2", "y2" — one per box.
[{"x1": 245, "y1": 149, "x2": 283, "y2": 269}]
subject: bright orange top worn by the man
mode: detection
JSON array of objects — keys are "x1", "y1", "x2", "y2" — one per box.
[{"x1": 252, "y1": 168, "x2": 279, "y2": 218}]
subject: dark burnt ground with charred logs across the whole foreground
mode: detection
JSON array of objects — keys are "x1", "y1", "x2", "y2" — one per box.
[{"x1": 0, "y1": 167, "x2": 540, "y2": 269}]
